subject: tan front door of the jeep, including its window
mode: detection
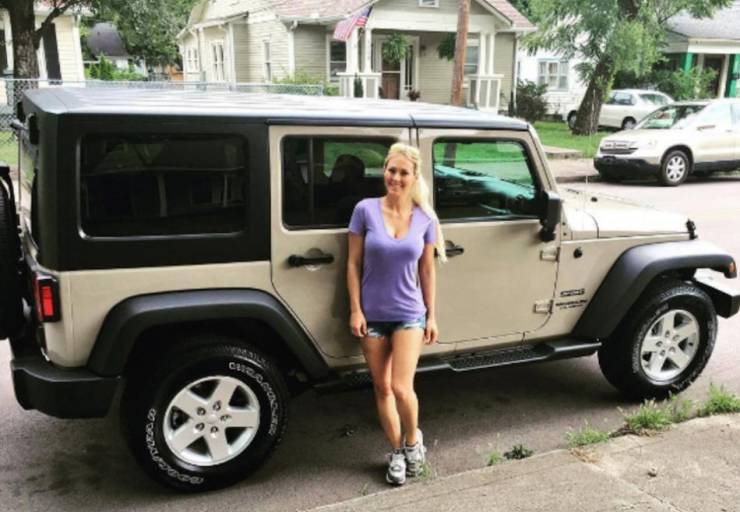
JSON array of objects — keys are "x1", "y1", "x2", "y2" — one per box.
[{"x1": 419, "y1": 129, "x2": 559, "y2": 351}]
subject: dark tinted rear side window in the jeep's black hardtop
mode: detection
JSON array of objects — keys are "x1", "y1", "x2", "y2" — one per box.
[{"x1": 80, "y1": 134, "x2": 247, "y2": 237}]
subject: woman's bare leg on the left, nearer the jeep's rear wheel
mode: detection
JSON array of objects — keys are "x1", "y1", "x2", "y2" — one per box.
[{"x1": 361, "y1": 337, "x2": 401, "y2": 448}]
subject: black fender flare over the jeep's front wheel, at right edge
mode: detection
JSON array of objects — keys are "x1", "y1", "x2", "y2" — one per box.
[{"x1": 573, "y1": 240, "x2": 736, "y2": 339}]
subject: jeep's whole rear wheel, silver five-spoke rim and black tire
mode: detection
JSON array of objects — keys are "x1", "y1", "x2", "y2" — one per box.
[{"x1": 121, "y1": 336, "x2": 288, "y2": 492}]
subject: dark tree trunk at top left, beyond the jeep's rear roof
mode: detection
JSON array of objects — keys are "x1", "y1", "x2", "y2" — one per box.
[{"x1": 5, "y1": 0, "x2": 39, "y2": 78}]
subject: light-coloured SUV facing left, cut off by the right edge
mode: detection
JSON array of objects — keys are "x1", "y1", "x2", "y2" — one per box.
[{"x1": 594, "y1": 99, "x2": 740, "y2": 186}]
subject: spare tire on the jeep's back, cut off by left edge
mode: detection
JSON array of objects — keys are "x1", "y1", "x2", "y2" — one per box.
[{"x1": 0, "y1": 182, "x2": 23, "y2": 339}]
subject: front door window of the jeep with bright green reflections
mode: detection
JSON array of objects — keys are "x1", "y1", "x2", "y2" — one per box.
[{"x1": 433, "y1": 140, "x2": 536, "y2": 220}]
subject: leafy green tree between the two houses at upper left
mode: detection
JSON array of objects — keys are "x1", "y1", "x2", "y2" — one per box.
[{"x1": 93, "y1": 0, "x2": 198, "y2": 65}]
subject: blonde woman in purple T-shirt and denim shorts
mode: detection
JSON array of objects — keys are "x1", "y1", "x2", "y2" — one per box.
[{"x1": 347, "y1": 143, "x2": 446, "y2": 485}]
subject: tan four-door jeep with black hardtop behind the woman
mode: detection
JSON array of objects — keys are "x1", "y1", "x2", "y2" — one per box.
[{"x1": 0, "y1": 88, "x2": 740, "y2": 491}]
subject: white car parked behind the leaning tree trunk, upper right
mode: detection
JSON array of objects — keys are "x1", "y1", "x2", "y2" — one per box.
[{"x1": 567, "y1": 89, "x2": 673, "y2": 130}]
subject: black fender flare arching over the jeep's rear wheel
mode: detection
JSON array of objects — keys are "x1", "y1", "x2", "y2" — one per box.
[{"x1": 88, "y1": 289, "x2": 329, "y2": 380}]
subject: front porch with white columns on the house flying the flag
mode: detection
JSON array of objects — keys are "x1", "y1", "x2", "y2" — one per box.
[{"x1": 337, "y1": 27, "x2": 504, "y2": 112}]
